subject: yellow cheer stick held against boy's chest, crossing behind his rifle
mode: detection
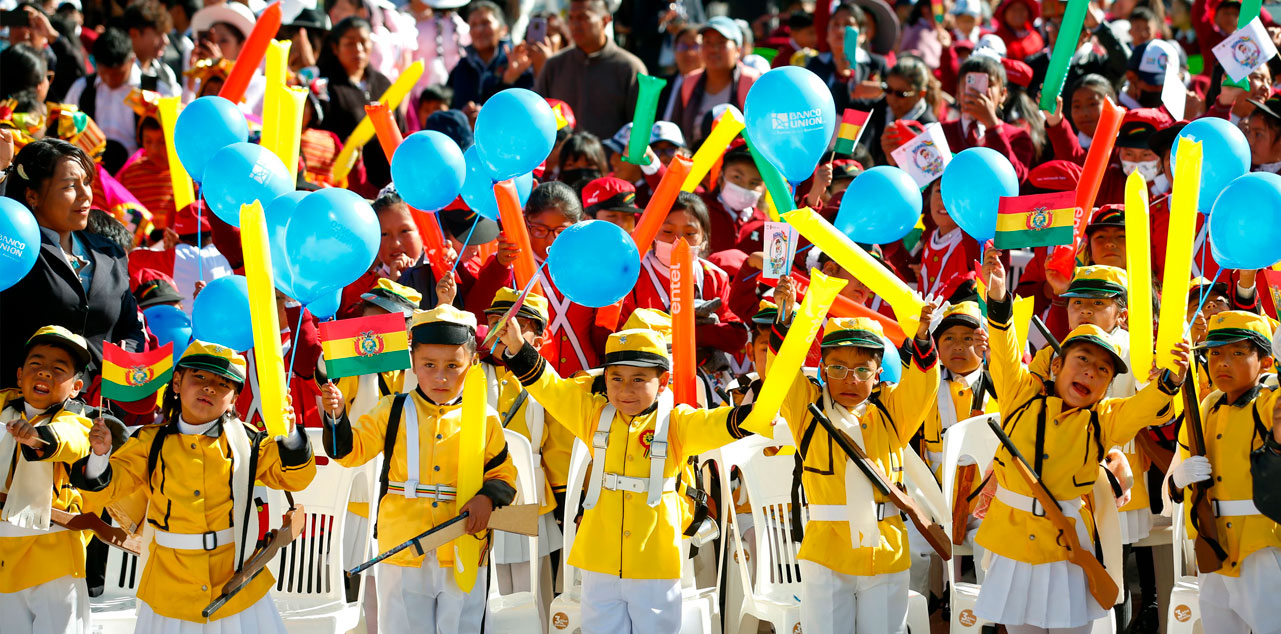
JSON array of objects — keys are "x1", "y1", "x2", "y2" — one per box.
[{"x1": 453, "y1": 364, "x2": 488, "y2": 592}]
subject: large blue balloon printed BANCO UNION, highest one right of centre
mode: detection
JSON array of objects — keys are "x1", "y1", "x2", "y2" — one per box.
[{"x1": 743, "y1": 67, "x2": 836, "y2": 183}]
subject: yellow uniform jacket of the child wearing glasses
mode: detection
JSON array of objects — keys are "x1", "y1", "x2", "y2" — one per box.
[{"x1": 779, "y1": 341, "x2": 939, "y2": 576}]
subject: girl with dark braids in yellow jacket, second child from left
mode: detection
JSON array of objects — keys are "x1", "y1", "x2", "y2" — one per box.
[{"x1": 73, "y1": 341, "x2": 315, "y2": 633}]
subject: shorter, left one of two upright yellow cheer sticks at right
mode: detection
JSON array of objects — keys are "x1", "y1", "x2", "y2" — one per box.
[{"x1": 1125, "y1": 172, "x2": 1158, "y2": 375}]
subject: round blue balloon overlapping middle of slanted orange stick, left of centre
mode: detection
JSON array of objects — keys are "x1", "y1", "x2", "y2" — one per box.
[{"x1": 392, "y1": 131, "x2": 466, "y2": 211}]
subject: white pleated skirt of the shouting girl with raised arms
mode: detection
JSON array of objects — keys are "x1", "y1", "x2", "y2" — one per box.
[{"x1": 974, "y1": 553, "x2": 1107, "y2": 629}]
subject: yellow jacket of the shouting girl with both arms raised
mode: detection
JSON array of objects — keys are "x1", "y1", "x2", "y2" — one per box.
[{"x1": 977, "y1": 298, "x2": 1179, "y2": 565}]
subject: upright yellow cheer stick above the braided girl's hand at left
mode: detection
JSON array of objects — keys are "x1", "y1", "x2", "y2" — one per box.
[{"x1": 241, "y1": 200, "x2": 288, "y2": 435}]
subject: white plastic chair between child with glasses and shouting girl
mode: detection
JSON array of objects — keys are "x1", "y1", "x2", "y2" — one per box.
[{"x1": 940, "y1": 414, "x2": 1000, "y2": 634}]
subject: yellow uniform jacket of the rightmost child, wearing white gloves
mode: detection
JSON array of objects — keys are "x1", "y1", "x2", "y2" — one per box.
[{"x1": 1179, "y1": 384, "x2": 1281, "y2": 576}]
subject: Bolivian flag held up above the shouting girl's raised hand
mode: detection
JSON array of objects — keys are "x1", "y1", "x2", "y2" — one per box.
[{"x1": 993, "y1": 191, "x2": 1076, "y2": 250}]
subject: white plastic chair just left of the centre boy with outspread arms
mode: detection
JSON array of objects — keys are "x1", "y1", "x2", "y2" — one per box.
[{"x1": 485, "y1": 429, "x2": 547, "y2": 634}]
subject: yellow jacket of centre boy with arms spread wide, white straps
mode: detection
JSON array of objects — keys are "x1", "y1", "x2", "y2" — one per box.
[{"x1": 507, "y1": 343, "x2": 751, "y2": 579}]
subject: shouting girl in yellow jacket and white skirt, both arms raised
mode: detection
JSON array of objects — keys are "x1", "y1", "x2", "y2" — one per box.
[{"x1": 975, "y1": 248, "x2": 1189, "y2": 634}]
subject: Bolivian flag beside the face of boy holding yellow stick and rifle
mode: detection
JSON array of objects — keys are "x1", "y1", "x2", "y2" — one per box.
[{"x1": 320, "y1": 313, "x2": 411, "y2": 379}]
